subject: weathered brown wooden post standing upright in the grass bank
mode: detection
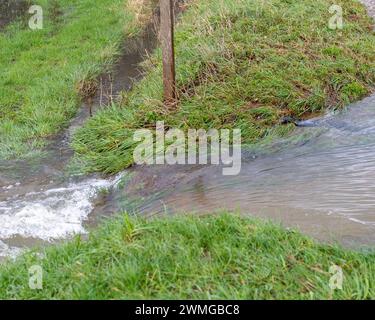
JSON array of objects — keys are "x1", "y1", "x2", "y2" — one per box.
[{"x1": 160, "y1": 0, "x2": 176, "y2": 108}]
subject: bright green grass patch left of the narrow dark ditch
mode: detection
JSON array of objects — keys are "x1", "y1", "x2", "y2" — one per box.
[{"x1": 0, "y1": 0, "x2": 138, "y2": 158}]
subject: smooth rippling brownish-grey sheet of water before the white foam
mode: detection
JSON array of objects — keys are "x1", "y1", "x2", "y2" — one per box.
[{"x1": 117, "y1": 95, "x2": 375, "y2": 247}]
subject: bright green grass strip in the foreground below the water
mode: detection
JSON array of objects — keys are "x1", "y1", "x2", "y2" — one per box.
[{"x1": 0, "y1": 213, "x2": 375, "y2": 299}]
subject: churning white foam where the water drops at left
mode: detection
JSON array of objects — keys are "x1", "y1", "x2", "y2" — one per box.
[{"x1": 0, "y1": 177, "x2": 120, "y2": 242}]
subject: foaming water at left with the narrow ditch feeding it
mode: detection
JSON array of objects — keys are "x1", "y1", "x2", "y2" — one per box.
[{"x1": 0, "y1": 17, "x2": 157, "y2": 260}]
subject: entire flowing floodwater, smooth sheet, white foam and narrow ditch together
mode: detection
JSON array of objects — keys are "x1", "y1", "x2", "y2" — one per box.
[{"x1": 0, "y1": 0, "x2": 375, "y2": 259}]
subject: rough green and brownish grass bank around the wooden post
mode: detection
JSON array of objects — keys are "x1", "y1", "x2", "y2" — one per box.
[{"x1": 73, "y1": 0, "x2": 375, "y2": 173}]
